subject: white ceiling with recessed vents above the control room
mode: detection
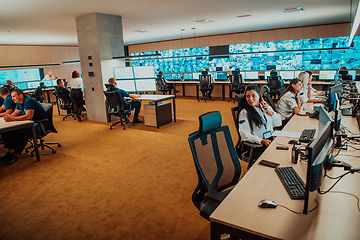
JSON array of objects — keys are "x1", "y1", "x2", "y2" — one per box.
[{"x1": 0, "y1": 0, "x2": 358, "y2": 45}]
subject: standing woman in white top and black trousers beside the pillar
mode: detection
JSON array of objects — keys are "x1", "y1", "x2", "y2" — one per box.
[{"x1": 70, "y1": 71, "x2": 84, "y2": 122}]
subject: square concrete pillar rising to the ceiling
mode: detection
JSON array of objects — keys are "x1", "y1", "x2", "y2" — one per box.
[{"x1": 76, "y1": 13, "x2": 125, "y2": 122}]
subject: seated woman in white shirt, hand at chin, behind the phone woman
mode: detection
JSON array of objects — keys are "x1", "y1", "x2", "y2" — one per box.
[{"x1": 277, "y1": 78, "x2": 302, "y2": 124}]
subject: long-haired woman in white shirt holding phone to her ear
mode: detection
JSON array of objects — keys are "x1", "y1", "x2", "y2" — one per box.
[{"x1": 239, "y1": 84, "x2": 281, "y2": 159}]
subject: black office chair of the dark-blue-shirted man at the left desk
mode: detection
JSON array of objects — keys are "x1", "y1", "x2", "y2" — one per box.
[{"x1": 25, "y1": 103, "x2": 61, "y2": 157}]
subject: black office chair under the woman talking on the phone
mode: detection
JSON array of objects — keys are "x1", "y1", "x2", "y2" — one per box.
[{"x1": 231, "y1": 93, "x2": 263, "y2": 169}]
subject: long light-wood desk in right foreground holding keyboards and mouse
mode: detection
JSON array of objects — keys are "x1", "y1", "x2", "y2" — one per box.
[{"x1": 210, "y1": 116, "x2": 360, "y2": 239}]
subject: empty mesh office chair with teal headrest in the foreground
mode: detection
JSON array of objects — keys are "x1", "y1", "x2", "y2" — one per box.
[{"x1": 188, "y1": 111, "x2": 241, "y2": 220}]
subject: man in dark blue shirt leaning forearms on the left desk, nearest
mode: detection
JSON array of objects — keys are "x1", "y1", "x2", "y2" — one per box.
[{"x1": 0, "y1": 88, "x2": 50, "y2": 165}]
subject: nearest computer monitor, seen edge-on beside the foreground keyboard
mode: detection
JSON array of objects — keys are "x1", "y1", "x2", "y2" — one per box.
[{"x1": 303, "y1": 121, "x2": 334, "y2": 214}]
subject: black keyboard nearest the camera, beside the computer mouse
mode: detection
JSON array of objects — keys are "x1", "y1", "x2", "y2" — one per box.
[{"x1": 275, "y1": 167, "x2": 305, "y2": 199}]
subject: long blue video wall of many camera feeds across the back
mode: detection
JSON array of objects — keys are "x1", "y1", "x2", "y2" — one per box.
[{"x1": 131, "y1": 36, "x2": 360, "y2": 73}]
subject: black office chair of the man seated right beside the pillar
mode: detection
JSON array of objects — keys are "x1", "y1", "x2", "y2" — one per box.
[{"x1": 104, "y1": 84, "x2": 135, "y2": 130}]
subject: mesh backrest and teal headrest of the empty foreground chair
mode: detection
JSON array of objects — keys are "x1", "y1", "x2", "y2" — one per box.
[{"x1": 188, "y1": 111, "x2": 241, "y2": 196}]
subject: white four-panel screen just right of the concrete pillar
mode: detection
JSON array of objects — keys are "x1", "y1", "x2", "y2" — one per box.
[{"x1": 114, "y1": 66, "x2": 156, "y2": 92}]
